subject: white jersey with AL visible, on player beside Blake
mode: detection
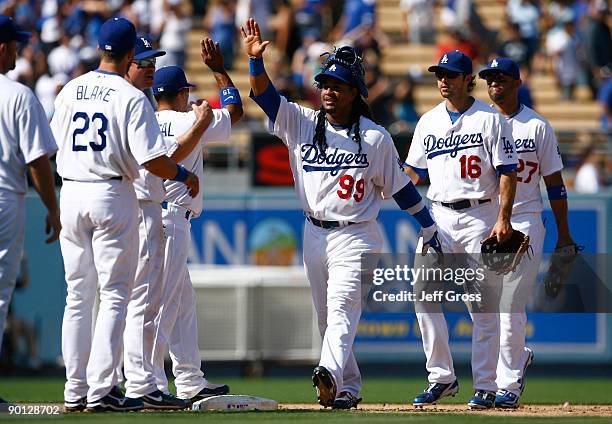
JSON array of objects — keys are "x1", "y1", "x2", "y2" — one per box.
[{"x1": 156, "y1": 109, "x2": 232, "y2": 216}]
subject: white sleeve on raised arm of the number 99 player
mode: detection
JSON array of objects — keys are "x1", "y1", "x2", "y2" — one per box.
[{"x1": 268, "y1": 96, "x2": 317, "y2": 148}]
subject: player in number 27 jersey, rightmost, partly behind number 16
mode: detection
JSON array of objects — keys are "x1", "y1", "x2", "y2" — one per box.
[{"x1": 478, "y1": 57, "x2": 574, "y2": 408}]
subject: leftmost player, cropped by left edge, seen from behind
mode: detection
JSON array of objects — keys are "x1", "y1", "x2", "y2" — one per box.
[{"x1": 0, "y1": 15, "x2": 61, "y2": 404}]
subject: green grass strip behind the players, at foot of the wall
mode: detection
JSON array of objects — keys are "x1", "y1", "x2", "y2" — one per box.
[{"x1": 0, "y1": 375, "x2": 612, "y2": 405}]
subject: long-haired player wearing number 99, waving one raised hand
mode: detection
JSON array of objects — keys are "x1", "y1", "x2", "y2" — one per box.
[{"x1": 242, "y1": 19, "x2": 439, "y2": 409}]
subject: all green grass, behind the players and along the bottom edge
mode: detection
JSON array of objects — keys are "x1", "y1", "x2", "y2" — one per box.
[{"x1": 0, "y1": 375, "x2": 612, "y2": 424}]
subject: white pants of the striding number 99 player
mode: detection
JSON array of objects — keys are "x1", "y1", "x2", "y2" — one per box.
[{"x1": 304, "y1": 220, "x2": 383, "y2": 395}]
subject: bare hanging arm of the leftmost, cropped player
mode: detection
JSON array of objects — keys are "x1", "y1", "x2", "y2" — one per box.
[{"x1": 28, "y1": 155, "x2": 62, "y2": 243}]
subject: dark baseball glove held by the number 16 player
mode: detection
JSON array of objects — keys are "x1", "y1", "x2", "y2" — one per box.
[{"x1": 480, "y1": 230, "x2": 530, "y2": 274}]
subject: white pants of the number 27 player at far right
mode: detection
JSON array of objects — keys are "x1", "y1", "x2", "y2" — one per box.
[{"x1": 497, "y1": 213, "x2": 546, "y2": 396}]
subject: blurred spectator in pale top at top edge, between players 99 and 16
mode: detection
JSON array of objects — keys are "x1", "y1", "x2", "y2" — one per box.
[{"x1": 400, "y1": 0, "x2": 436, "y2": 44}]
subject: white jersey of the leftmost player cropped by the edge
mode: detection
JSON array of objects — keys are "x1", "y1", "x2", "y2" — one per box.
[{"x1": 0, "y1": 74, "x2": 57, "y2": 194}]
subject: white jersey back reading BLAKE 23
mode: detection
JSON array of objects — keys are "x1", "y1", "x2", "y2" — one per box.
[{"x1": 51, "y1": 70, "x2": 166, "y2": 181}]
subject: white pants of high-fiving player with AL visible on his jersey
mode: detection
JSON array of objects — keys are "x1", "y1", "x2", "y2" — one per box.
[{"x1": 153, "y1": 203, "x2": 208, "y2": 399}]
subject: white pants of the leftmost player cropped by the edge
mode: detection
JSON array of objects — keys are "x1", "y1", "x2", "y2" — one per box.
[{"x1": 0, "y1": 189, "x2": 25, "y2": 354}]
